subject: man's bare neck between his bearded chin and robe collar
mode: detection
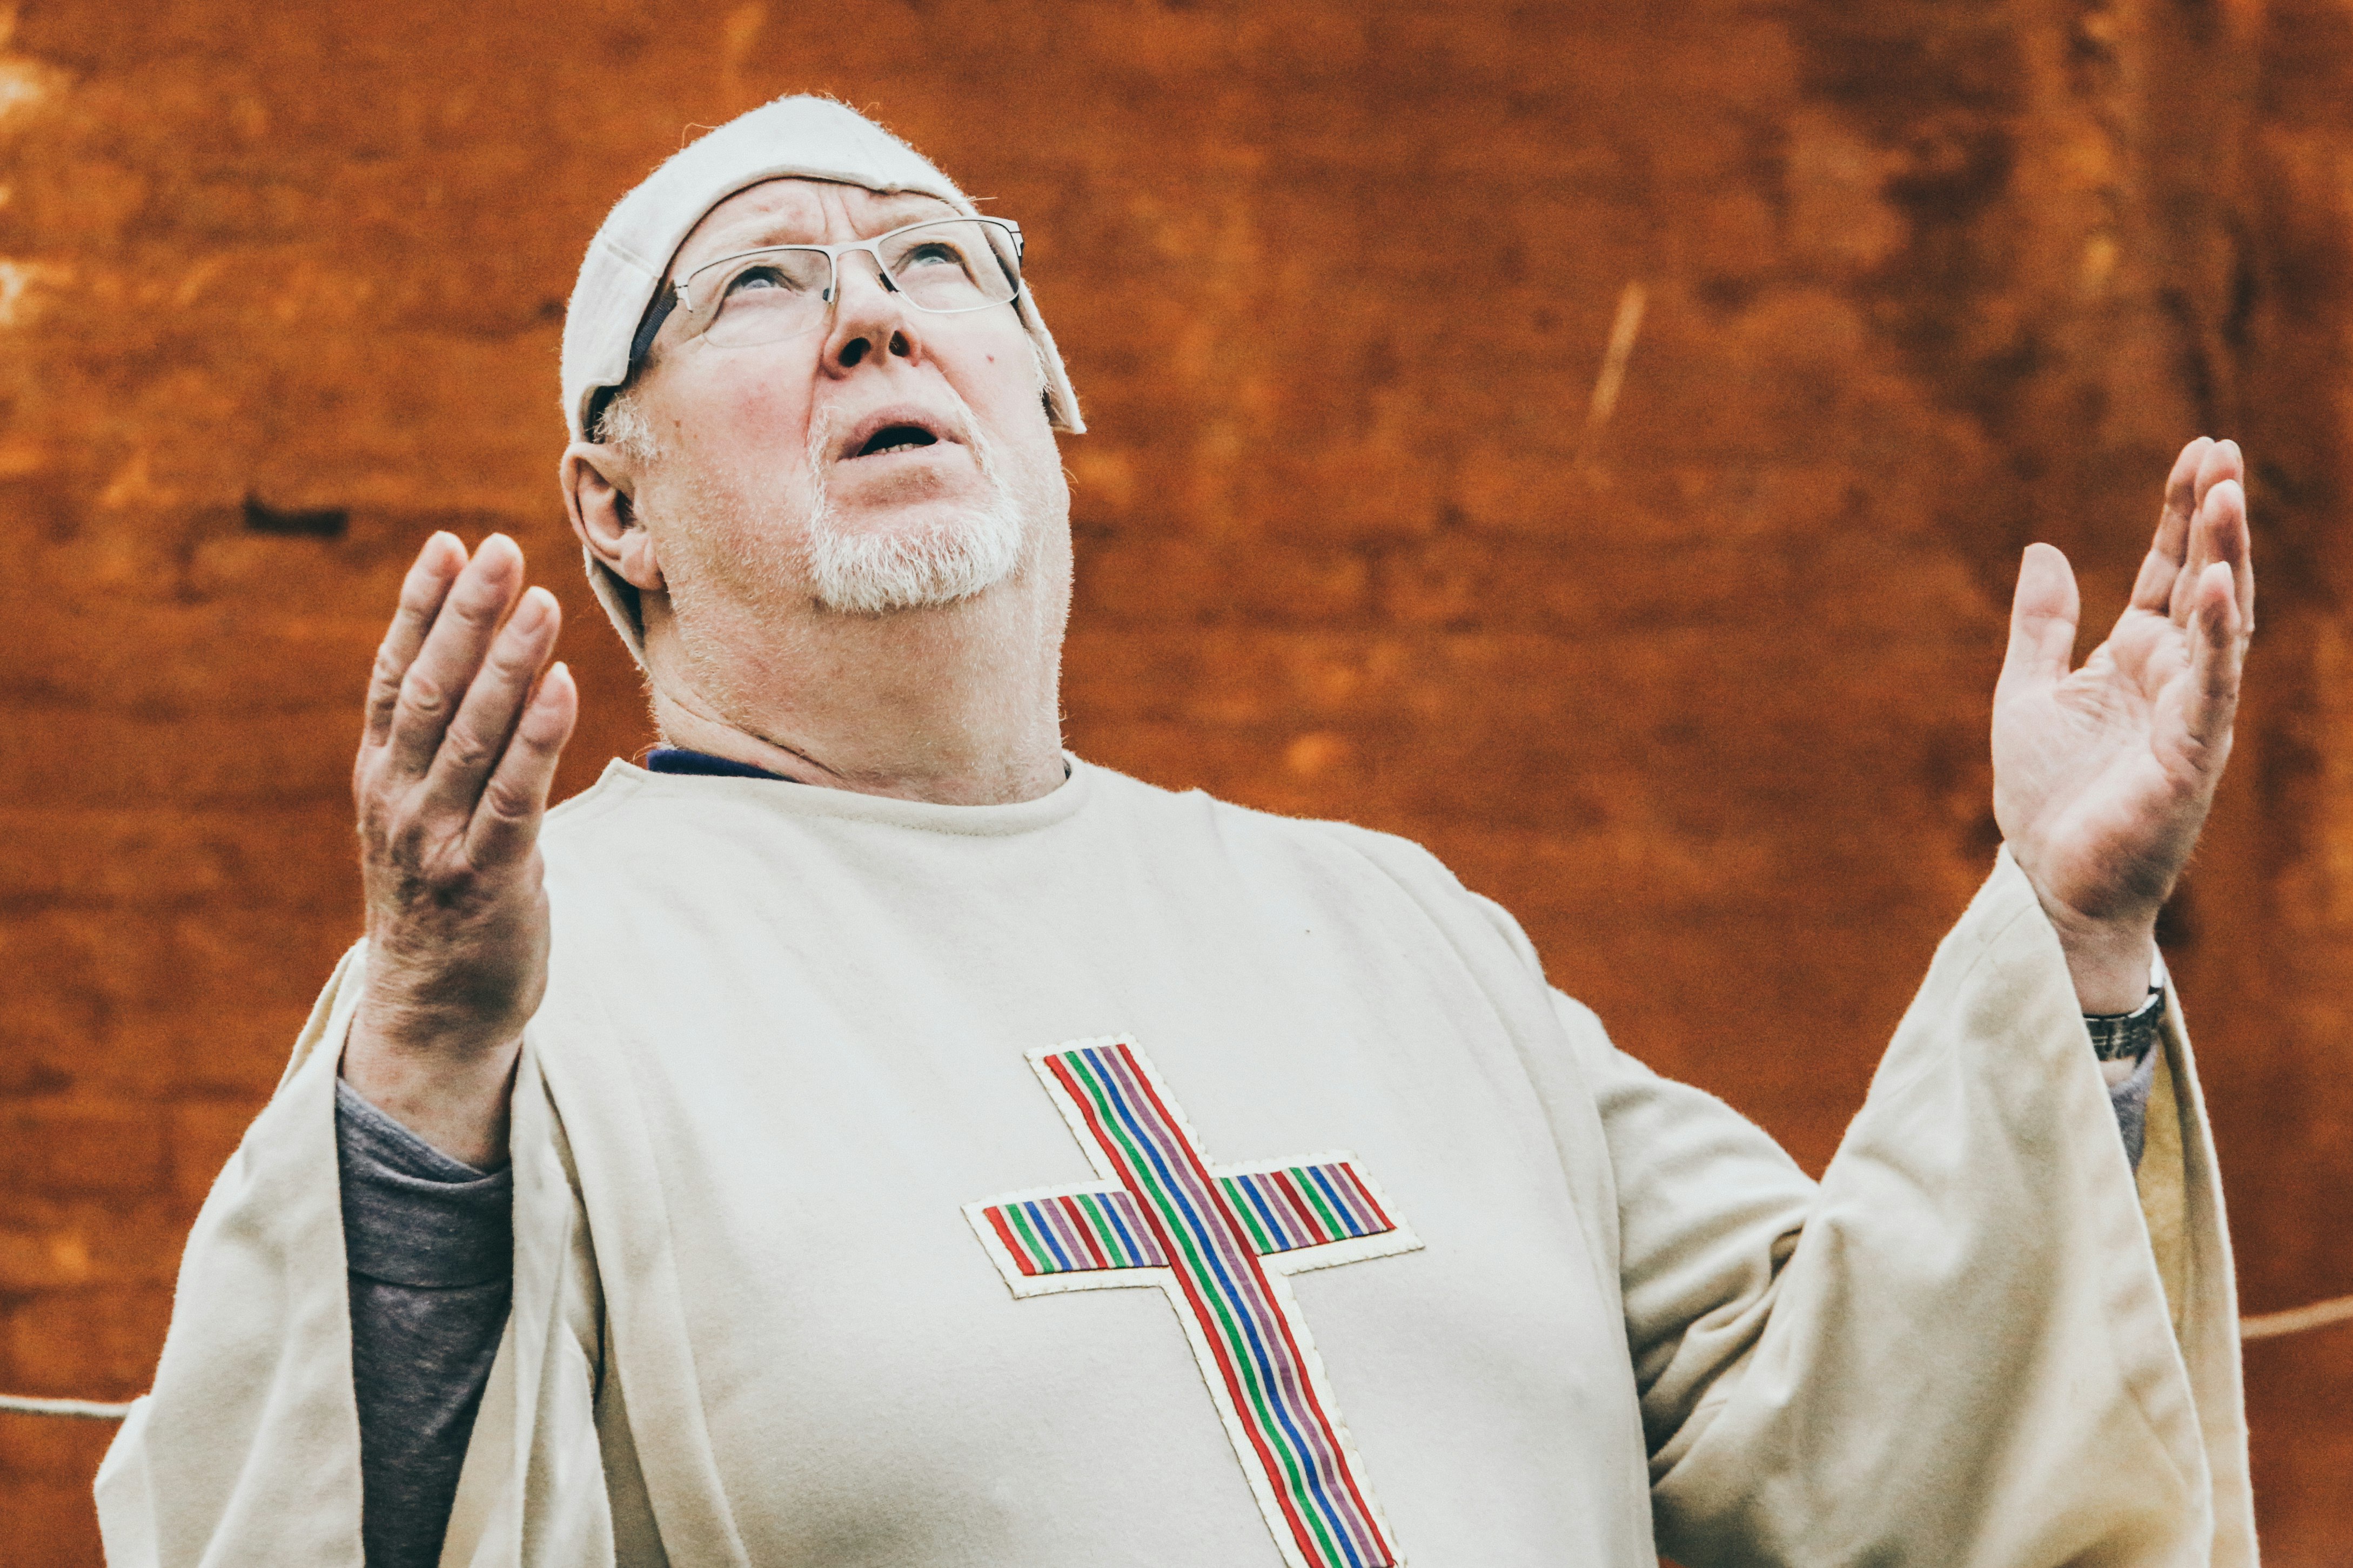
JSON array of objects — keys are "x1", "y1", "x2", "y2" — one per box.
[{"x1": 642, "y1": 553, "x2": 1068, "y2": 806}]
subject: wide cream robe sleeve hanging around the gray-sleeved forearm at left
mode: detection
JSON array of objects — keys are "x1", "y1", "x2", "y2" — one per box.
[{"x1": 97, "y1": 945, "x2": 614, "y2": 1568}]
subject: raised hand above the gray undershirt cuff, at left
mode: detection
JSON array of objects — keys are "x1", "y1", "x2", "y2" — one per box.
[{"x1": 344, "y1": 534, "x2": 579, "y2": 1166}]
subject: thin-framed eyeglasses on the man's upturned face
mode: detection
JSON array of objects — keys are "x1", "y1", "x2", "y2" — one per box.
[{"x1": 628, "y1": 219, "x2": 1021, "y2": 365}]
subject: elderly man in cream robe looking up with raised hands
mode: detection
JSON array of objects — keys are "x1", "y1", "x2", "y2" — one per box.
[{"x1": 99, "y1": 99, "x2": 2254, "y2": 1568}]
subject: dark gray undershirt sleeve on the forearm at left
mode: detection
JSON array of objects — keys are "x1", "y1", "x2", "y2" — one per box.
[{"x1": 334, "y1": 1079, "x2": 515, "y2": 1568}]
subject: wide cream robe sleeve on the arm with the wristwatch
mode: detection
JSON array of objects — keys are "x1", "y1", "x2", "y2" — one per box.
[{"x1": 1560, "y1": 851, "x2": 2256, "y2": 1568}]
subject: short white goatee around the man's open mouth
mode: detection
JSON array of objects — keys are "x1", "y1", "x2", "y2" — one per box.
[{"x1": 802, "y1": 421, "x2": 1026, "y2": 616}]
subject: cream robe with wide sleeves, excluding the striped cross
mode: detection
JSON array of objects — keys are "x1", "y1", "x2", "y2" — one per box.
[{"x1": 97, "y1": 762, "x2": 2254, "y2": 1568}]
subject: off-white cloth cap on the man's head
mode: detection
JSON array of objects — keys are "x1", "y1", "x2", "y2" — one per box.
[{"x1": 562, "y1": 96, "x2": 1087, "y2": 665}]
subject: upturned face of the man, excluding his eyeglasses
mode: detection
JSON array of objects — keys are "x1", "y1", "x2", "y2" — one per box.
[{"x1": 631, "y1": 179, "x2": 1068, "y2": 625}]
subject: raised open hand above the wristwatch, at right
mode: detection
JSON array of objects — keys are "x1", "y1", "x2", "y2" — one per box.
[{"x1": 1993, "y1": 438, "x2": 2254, "y2": 1013}]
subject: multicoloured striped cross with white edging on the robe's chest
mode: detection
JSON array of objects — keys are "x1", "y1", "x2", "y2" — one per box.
[{"x1": 965, "y1": 1037, "x2": 1421, "y2": 1568}]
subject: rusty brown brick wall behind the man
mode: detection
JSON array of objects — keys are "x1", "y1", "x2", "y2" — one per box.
[{"x1": 0, "y1": 0, "x2": 2353, "y2": 1568}]
